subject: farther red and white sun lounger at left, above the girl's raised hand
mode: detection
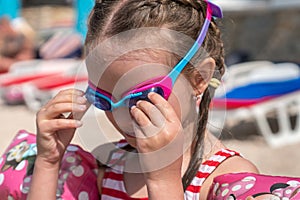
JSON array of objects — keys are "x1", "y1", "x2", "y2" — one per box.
[{"x1": 0, "y1": 59, "x2": 82, "y2": 104}]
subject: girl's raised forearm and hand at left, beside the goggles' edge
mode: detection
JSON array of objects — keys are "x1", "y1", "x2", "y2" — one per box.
[{"x1": 28, "y1": 89, "x2": 87, "y2": 200}]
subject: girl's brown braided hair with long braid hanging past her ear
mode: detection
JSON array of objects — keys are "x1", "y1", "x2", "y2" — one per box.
[{"x1": 86, "y1": 0, "x2": 225, "y2": 189}]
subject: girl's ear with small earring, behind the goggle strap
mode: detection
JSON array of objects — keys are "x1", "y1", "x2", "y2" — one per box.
[{"x1": 191, "y1": 57, "x2": 216, "y2": 96}]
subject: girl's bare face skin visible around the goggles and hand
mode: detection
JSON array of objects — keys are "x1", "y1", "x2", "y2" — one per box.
[{"x1": 94, "y1": 55, "x2": 197, "y2": 147}]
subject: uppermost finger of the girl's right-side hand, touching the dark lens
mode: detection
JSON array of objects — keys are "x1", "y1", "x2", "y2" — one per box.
[{"x1": 148, "y1": 92, "x2": 177, "y2": 122}]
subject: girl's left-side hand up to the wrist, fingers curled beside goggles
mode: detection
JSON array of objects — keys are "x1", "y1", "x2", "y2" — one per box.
[{"x1": 36, "y1": 89, "x2": 87, "y2": 166}]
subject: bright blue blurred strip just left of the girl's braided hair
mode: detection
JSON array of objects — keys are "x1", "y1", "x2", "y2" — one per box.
[{"x1": 74, "y1": 0, "x2": 95, "y2": 40}]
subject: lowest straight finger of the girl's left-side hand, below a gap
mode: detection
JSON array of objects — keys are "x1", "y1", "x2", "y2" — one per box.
[{"x1": 39, "y1": 119, "x2": 82, "y2": 133}]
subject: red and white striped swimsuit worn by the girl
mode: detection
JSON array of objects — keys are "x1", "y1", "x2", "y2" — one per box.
[{"x1": 101, "y1": 140, "x2": 240, "y2": 200}]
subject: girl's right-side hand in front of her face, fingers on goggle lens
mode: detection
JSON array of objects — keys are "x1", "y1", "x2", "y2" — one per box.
[{"x1": 131, "y1": 93, "x2": 184, "y2": 184}]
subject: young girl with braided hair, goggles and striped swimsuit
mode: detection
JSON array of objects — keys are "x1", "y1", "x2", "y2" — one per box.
[{"x1": 28, "y1": 0, "x2": 257, "y2": 200}]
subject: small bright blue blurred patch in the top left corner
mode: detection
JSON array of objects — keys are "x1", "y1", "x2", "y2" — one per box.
[{"x1": 0, "y1": 0, "x2": 21, "y2": 19}]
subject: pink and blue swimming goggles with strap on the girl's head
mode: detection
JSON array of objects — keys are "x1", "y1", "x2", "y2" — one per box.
[{"x1": 85, "y1": 1, "x2": 223, "y2": 111}]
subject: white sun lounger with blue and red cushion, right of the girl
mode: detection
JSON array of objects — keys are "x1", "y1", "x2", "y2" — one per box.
[{"x1": 210, "y1": 62, "x2": 300, "y2": 147}]
